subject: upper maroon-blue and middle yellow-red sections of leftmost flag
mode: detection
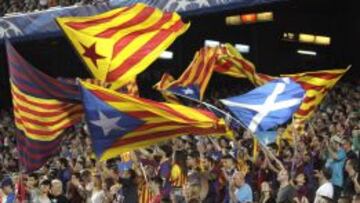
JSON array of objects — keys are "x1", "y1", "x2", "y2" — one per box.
[{"x1": 6, "y1": 42, "x2": 83, "y2": 141}]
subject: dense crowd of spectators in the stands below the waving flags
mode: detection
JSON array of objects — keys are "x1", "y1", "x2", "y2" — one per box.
[{"x1": 0, "y1": 83, "x2": 360, "y2": 203}]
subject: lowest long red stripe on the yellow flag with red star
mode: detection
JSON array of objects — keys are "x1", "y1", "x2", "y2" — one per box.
[{"x1": 107, "y1": 20, "x2": 184, "y2": 82}]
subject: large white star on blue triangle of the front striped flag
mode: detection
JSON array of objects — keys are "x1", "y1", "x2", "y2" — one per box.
[{"x1": 90, "y1": 111, "x2": 125, "y2": 137}]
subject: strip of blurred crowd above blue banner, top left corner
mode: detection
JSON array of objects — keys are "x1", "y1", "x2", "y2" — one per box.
[{"x1": 0, "y1": 0, "x2": 108, "y2": 17}]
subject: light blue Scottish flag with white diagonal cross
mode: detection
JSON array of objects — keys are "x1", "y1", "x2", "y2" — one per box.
[{"x1": 221, "y1": 78, "x2": 305, "y2": 133}]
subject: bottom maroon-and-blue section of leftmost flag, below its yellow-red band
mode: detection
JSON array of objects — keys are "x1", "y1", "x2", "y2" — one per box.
[{"x1": 16, "y1": 133, "x2": 62, "y2": 172}]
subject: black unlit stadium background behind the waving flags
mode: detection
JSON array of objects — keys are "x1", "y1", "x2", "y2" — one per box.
[{"x1": 0, "y1": 0, "x2": 360, "y2": 108}]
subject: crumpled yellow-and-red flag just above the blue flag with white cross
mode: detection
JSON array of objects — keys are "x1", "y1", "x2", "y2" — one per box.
[{"x1": 215, "y1": 44, "x2": 277, "y2": 86}]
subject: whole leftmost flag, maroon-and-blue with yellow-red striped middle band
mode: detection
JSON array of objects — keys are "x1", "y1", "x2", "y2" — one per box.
[{"x1": 6, "y1": 41, "x2": 83, "y2": 172}]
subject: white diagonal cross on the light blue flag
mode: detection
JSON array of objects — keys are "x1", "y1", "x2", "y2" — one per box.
[{"x1": 221, "y1": 78, "x2": 302, "y2": 132}]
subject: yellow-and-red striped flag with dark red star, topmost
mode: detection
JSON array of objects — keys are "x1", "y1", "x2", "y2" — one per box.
[{"x1": 57, "y1": 3, "x2": 190, "y2": 89}]
